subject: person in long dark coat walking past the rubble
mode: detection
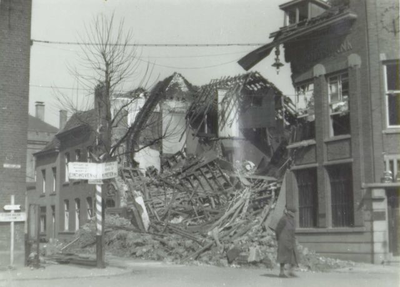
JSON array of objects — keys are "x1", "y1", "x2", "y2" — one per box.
[{"x1": 275, "y1": 208, "x2": 298, "y2": 277}]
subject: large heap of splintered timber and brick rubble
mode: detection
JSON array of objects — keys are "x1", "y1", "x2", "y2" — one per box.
[{"x1": 68, "y1": 155, "x2": 349, "y2": 271}]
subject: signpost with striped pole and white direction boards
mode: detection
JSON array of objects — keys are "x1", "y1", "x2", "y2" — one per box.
[{"x1": 68, "y1": 161, "x2": 118, "y2": 268}]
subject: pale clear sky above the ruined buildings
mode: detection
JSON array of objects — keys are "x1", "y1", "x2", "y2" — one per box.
[{"x1": 29, "y1": 0, "x2": 294, "y2": 127}]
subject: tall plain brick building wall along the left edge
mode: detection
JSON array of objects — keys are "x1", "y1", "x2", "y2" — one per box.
[{"x1": 0, "y1": 0, "x2": 32, "y2": 265}]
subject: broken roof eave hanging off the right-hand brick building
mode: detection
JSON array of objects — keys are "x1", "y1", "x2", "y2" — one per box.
[{"x1": 238, "y1": 5, "x2": 357, "y2": 71}]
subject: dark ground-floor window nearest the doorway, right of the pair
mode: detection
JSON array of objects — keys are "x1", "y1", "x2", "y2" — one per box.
[{"x1": 328, "y1": 165, "x2": 354, "y2": 227}]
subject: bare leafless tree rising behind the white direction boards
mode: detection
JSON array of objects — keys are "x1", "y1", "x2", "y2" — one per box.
[{"x1": 56, "y1": 14, "x2": 189, "y2": 168}]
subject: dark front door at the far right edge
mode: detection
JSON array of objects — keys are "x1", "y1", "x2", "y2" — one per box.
[{"x1": 387, "y1": 188, "x2": 400, "y2": 256}]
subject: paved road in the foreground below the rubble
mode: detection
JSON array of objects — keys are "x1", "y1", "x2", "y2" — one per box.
[{"x1": 0, "y1": 262, "x2": 400, "y2": 287}]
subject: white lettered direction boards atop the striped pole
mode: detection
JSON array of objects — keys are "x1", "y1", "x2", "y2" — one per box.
[{"x1": 68, "y1": 161, "x2": 118, "y2": 180}]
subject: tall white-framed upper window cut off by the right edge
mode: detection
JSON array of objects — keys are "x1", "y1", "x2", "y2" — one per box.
[{"x1": 385, "y1": 61, "x2": 400, "y2": 127}]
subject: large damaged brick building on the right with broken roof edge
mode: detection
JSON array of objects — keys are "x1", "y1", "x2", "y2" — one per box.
[{"x1": 239, "y1": 0, "x2": 400, "y2": 263}]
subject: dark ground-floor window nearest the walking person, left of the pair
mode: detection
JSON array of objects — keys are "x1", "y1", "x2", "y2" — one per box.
[{"x1": 296, "y1": 168, "x2": 318, "y2": 227}]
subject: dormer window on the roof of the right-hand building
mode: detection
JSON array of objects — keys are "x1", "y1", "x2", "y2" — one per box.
[{"x1": 279, "y1": 0, "x2": 330, "y2": 26}]
